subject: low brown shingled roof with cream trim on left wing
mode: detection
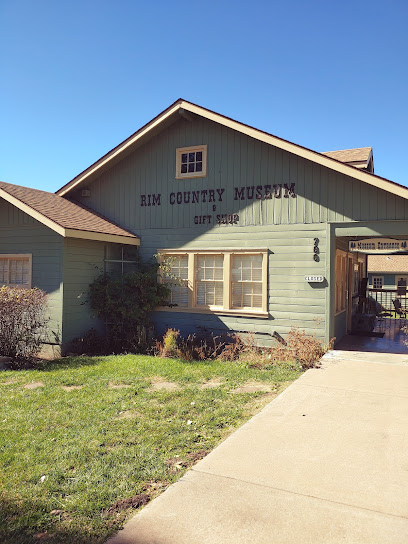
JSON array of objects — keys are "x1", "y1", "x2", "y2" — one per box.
[{"x1": 0, "y1": 182, "x2": 140, "y2": 245}]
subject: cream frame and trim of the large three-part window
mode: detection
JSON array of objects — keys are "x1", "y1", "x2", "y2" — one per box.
[{"x1": 158, "y1": 249, "x2": 269, "y2": 318}]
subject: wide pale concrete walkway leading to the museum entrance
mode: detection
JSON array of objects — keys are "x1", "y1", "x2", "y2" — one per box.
[{"x1": 108, "y1": 351, "x2": 408, "y2": 544}]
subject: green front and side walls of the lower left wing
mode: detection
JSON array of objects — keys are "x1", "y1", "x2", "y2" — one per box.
[{"x1": 0, "y1": 200, "x2": 113, "y2": 352}]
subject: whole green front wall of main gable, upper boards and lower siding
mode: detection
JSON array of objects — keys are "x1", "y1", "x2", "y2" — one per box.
[{"x1": 63, "y1": 113, "x2": 408, "y2": 343}]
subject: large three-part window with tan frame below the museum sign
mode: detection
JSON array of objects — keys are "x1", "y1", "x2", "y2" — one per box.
[{"x1": 159, "y1": 249, "x2": 268, "y2": 317}]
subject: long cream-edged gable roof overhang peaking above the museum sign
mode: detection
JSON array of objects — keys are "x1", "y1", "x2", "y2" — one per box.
[{"x1": 56, "y1": 98, "x2": 408, "y2": 199}]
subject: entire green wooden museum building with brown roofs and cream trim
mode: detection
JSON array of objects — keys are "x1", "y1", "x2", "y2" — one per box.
[{"x1": 0, "y1": 99, "x2": 408, "y2": 351}]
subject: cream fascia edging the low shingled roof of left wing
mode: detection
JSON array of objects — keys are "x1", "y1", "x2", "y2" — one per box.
[{"x1": 0, "y1": 188, "x2": 140, "y2": 246}]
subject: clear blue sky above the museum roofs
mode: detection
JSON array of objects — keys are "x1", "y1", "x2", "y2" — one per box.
[{"x1": 0, "y1": 0, "x2": 408, "y2": 191}]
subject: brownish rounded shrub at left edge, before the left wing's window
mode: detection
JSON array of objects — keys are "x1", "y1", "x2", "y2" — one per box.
[{"x1": 0, "y1": 286, "x2": 48, "y2": 359}]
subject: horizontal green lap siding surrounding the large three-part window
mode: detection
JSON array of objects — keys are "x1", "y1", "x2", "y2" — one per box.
[{"x1": 140, "y1": 225, "x2": 327, "y2": 343}]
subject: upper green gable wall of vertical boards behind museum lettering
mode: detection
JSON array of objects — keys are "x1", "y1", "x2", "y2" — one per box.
[{"x1": 73, "y1": 118, "x2": 408, "y2": 233}]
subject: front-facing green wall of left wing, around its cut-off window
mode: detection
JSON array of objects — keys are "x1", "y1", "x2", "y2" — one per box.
[{"x1": 0, "y1": 199, "x2": 63, "y2": 342}]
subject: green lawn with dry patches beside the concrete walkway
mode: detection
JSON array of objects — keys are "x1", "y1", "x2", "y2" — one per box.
[{"x1": 0, "y1": 355, "x2": 300, "y2": 544}]
